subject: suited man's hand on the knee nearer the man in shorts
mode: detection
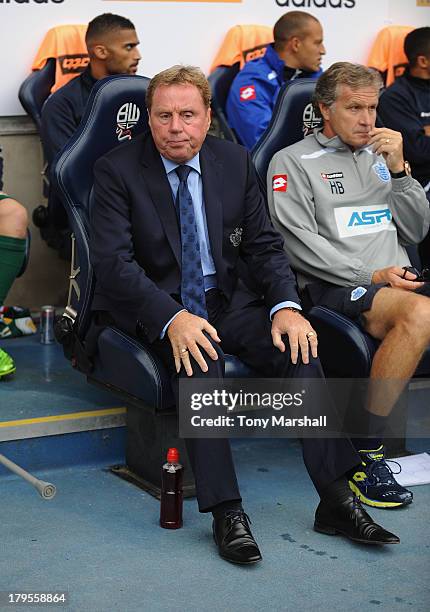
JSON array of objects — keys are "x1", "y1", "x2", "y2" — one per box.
[{"x1": 271, "y1": 308, "x2": 318, "y2": 364}]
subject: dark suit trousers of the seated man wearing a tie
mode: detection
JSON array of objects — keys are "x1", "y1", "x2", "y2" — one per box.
[{"x1": 152, "y1": 290, "x2": 360, "y2": 512}]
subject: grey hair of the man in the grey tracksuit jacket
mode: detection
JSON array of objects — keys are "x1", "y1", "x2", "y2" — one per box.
[{"x1": 313, "y1": 62, "x2": 382, "y2": 117}]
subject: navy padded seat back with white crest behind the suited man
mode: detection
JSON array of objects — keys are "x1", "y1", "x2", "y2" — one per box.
[{"x1": 52, "y1": 75, "x2": 149, "y2": 338}]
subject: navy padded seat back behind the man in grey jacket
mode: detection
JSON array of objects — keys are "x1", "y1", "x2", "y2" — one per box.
[{"x1": 251, "y1": 79, "x2": 321, "y2": 196}]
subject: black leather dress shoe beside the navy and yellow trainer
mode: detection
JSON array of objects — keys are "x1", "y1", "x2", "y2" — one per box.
[{"x1": 314, "y1": 494, "x2": 400, "y2": 544}]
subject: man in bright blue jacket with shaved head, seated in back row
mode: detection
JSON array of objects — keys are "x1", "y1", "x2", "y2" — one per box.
[{"x1": 226, "y1": 11, "x2": 325, "y2": 149}]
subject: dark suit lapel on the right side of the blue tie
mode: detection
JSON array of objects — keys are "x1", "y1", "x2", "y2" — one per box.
[{"x1": 200, "y1": 143, "x2": 223, "y2": 272}]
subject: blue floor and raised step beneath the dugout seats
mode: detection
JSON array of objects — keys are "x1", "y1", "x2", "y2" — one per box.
[{"x1": 0, "y1": 337, "x2": 430, "y2": 612}]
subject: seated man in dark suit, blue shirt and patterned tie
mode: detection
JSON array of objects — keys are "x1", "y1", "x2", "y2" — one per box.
[{"x1": 91, "y1": 66, "x2": 399, "y2": 563}]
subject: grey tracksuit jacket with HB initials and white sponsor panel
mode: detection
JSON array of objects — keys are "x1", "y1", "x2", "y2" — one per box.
[{"x1": 267, "y1": 128, "x2": 430, "y2": 288}]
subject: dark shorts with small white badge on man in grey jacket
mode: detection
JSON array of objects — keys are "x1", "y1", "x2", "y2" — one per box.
[{"x1": 305, "y1": 283, "x2": 430, "y2": 325}]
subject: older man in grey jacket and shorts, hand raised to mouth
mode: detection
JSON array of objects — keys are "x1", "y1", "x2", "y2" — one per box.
[{"x1": 268, "y1": 62, "x2": 430, "y2": 508}]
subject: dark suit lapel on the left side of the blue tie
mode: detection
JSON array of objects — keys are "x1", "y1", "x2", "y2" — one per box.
[{"x1": 142, "y1": 136, "x2": 181, "y2": 268}]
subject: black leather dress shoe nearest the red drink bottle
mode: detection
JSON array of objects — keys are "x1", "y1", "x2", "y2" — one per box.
[{"x1": 212, "y1": 510, "x2": 261, "y2": 564}]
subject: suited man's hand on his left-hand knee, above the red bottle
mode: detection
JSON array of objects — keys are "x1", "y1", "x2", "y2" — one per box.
[{"x1": 167, "y1": 310, "x2": 221, "y2": 376}]
